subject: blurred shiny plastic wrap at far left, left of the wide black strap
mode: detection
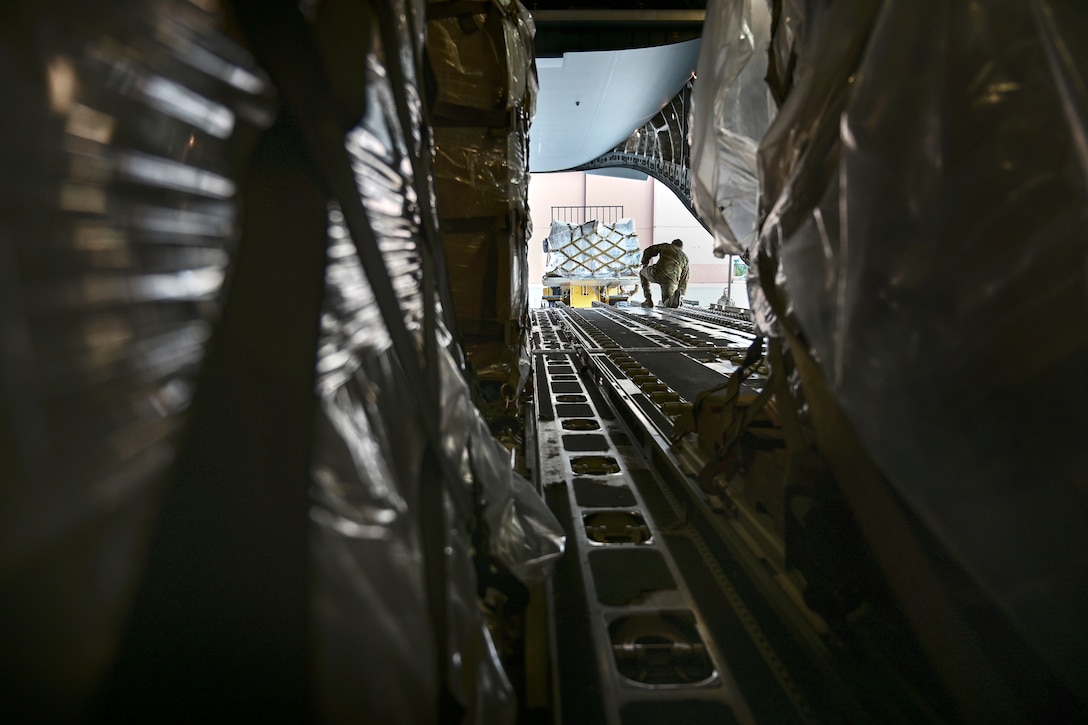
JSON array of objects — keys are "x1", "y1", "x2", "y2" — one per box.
[{"x1": 0, "y1": 0, "x2": 274, "y2": 720}]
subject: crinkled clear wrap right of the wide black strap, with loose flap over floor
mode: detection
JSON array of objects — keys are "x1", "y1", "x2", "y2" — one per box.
[{"x1": 311, "y1": 1, "x2": 564, "y2": 723}]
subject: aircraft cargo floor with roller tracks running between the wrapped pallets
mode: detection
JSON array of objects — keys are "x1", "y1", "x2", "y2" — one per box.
[{"x1": 530, "y1": 306, "x2": 944, "y2": 725}]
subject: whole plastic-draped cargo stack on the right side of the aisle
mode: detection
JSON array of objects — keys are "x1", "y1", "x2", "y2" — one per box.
[{"x1": 692, "y1": 0, "x2": 1088, "y2": 709}]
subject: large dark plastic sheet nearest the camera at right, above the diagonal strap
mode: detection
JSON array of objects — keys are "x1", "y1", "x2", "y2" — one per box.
[{"x1": 753, "y1": 0, "x2": 1088, "y2": 697}]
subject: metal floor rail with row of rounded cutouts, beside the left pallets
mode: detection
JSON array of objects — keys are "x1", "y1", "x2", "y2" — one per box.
[{"x1": 534, "y1": 352, "x2": 756, "y2": 725}]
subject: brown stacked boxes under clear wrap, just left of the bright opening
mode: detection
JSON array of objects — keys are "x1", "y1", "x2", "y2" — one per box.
[{"x1": 426, "y1": 0, "x2": 536, "y2": 390}]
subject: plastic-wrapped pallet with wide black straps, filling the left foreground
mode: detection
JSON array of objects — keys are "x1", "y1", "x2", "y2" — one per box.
[{"x1": 0, "y1": 0, "x2": 562, "y2": 723}]
